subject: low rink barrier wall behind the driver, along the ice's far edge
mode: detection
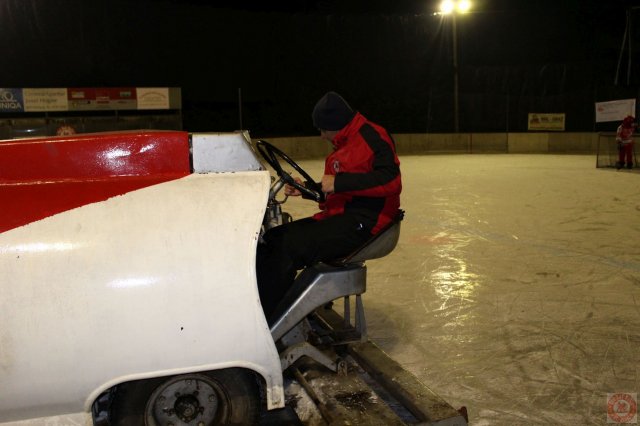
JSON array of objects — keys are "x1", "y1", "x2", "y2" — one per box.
[{"x1": 256, "y1": 132, "x2": 599, "y2": 159}]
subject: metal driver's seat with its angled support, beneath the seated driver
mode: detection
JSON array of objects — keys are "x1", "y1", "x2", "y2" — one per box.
[{"x1": 269, "y1": 210, "x2": 404, "y2": 371}]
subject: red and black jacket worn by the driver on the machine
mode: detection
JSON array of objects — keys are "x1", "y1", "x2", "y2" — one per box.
[{"x1": 314, "y1": 113, "x2": 402, "y2": 234}]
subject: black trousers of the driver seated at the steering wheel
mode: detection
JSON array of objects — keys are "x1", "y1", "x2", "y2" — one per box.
[{"x1": 256, "y1": 214, "x2": 371, "y2": 319}]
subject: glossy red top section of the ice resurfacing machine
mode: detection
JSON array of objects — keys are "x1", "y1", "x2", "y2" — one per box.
[{"x1": 0, "y1": 131, "x2": 190, "y2": 233}]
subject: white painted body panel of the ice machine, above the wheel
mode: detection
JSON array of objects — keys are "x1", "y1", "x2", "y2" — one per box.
[{"x1": 0, "y1": 131, "x2": 284, "y2": 425}]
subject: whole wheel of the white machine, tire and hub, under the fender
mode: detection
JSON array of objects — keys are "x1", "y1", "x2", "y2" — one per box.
[{"x1": 109, "y1": 369, "x2": 261, "y2": 426}]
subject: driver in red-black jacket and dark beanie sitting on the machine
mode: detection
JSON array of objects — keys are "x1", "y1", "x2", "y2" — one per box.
[{"x1": 256, "y1": 92, "x2": 402, "y2": 319}]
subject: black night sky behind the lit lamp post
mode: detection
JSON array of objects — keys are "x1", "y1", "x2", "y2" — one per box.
[{"x1": 0, "y1": 0, "x2": 640, "y2": 136}]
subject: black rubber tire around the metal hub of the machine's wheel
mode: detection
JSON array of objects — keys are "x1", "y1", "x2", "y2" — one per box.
[{"x1": 109, "y1": 368, "x2": 262, "y2": 426}]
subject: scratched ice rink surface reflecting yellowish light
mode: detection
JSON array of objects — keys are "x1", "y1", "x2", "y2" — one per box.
[{"x1": 285, "y1": 154, "x2": 640, "y2": 425}]
